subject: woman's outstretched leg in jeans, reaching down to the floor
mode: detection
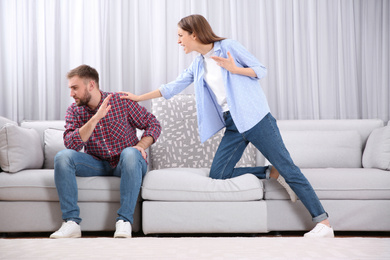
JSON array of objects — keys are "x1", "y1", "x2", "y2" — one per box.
[{"x1": 244, "y1": 113, "x2": 328, "y2": 222}]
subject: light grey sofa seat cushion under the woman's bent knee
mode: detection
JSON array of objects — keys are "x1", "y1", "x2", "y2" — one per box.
[{"x1": 142, "y1": 168, "x2": 263, "y2": 201}]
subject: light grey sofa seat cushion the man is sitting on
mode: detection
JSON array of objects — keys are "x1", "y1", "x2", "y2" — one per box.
[{"x1": 0, "y1": 169, "x2": 120, "y2": 202}]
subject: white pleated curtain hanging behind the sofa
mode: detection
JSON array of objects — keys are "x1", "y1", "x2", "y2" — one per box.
[{"x1": 0, "y1": 0, "x2": 390, "y2": 122}]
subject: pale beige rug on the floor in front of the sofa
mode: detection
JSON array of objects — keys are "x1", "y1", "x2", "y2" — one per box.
[{"x1": 0, "y1": 237, "x2": 390, "y2": 260}]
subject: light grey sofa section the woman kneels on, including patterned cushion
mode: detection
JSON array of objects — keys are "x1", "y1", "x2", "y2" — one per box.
[{"x1": 142, "y1": 95, "x2": 390, "y2": 234}]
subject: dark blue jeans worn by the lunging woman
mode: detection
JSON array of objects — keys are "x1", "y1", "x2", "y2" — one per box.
[{"x1": 210, "y1": 112, "x2": 328, "y2": 222}]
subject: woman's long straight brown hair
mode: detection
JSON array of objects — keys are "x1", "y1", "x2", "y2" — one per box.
[{"x1": 178, "y1": 14, "x2": 225, "y2": 44}]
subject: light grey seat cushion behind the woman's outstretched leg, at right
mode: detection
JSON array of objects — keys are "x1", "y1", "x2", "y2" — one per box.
[{"x1": 264, "y1": 168, "x2": 390, "y2": 200}]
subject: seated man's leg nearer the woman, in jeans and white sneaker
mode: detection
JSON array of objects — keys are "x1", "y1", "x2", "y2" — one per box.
[{"x1": 114, "y1": 147, "x2": 147, "y2": 237}]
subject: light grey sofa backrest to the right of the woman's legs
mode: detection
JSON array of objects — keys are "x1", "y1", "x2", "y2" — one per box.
[{"x1": 258, "y1": 119, "x2": 384, "y2": 168}]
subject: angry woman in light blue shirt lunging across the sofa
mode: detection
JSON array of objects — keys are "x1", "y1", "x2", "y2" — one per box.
[{"x1": 122, "y1": 15, "x2": 334, "y2": 237}]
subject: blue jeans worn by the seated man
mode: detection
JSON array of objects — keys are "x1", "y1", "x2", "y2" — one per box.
[{"x1": 54, "y1": 147, "x2": 147, "y2": 223}]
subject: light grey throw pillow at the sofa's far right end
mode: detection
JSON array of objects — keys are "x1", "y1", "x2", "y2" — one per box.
[{"x1": 363, "y1": 125, "x2": 390, "y2": 171}]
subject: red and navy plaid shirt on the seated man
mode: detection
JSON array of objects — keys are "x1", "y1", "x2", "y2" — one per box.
[{"x1": 64, "y1": 91, "x2": 161, "y2": 168}]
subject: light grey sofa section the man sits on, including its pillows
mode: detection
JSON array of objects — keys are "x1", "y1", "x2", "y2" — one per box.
[{"x1": 0, "y1": 117, "x2": 141, "y2": 233}]
